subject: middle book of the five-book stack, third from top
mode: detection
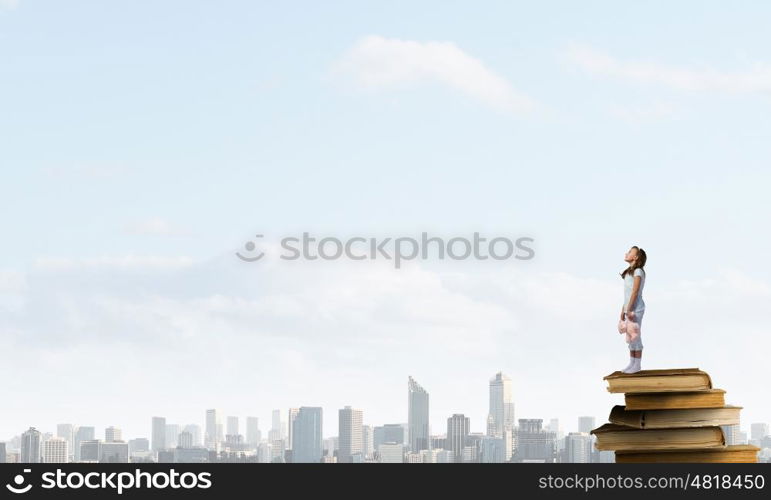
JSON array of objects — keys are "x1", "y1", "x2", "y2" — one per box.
[{"x1": 608, "y1": 405, "x2": 742, "y2": 429}]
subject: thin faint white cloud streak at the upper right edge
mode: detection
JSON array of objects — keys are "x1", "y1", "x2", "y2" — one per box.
[{"x1": 566, "y1": 44, "x2": 771, "y2": 93}]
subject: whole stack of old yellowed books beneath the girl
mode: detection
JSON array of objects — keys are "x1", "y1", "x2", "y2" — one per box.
[{"x1": 591, "y1": 368, "x2": 760, "y2": 463}]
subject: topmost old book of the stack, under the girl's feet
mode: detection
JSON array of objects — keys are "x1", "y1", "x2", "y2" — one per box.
[{"x1": 603, "y1": 368, "x2": 712, "y2": 393}]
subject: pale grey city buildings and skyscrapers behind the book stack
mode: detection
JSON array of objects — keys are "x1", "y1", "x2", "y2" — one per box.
[{"x1": 0, "y1": 372, "x2": 771, "y2": 463}]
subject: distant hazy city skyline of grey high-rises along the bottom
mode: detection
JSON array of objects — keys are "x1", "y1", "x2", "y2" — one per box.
[{"x1": 6, "y1": 372, "x2": 771, "y2": 463}]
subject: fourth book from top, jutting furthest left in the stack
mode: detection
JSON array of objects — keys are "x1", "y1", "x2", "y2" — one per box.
[{"x1": 590, "y1": 423, "x2": 725, "y2": 450}]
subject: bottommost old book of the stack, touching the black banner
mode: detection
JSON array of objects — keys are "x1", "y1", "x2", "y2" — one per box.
[{"x1": 616, "y1": 444, "x2": 760, "y2": 464}]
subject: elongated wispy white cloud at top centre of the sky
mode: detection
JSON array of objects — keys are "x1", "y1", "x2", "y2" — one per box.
[{"x1": 332, "y1": 35, "x2": 535, "y2": 113}]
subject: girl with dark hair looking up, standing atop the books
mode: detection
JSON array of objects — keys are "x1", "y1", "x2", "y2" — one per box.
[{"x1": 619, "y1": 246, "x2": 647, "y2": 373}]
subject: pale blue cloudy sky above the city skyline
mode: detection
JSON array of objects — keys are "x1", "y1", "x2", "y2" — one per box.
[{"x1": 0, "y1": 0, "x2": 771, "y2": 439}]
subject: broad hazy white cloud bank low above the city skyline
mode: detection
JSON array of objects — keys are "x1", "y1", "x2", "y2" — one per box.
[{"x1": 0, "y1": 255, "x2": 771, "y2": 436}]
